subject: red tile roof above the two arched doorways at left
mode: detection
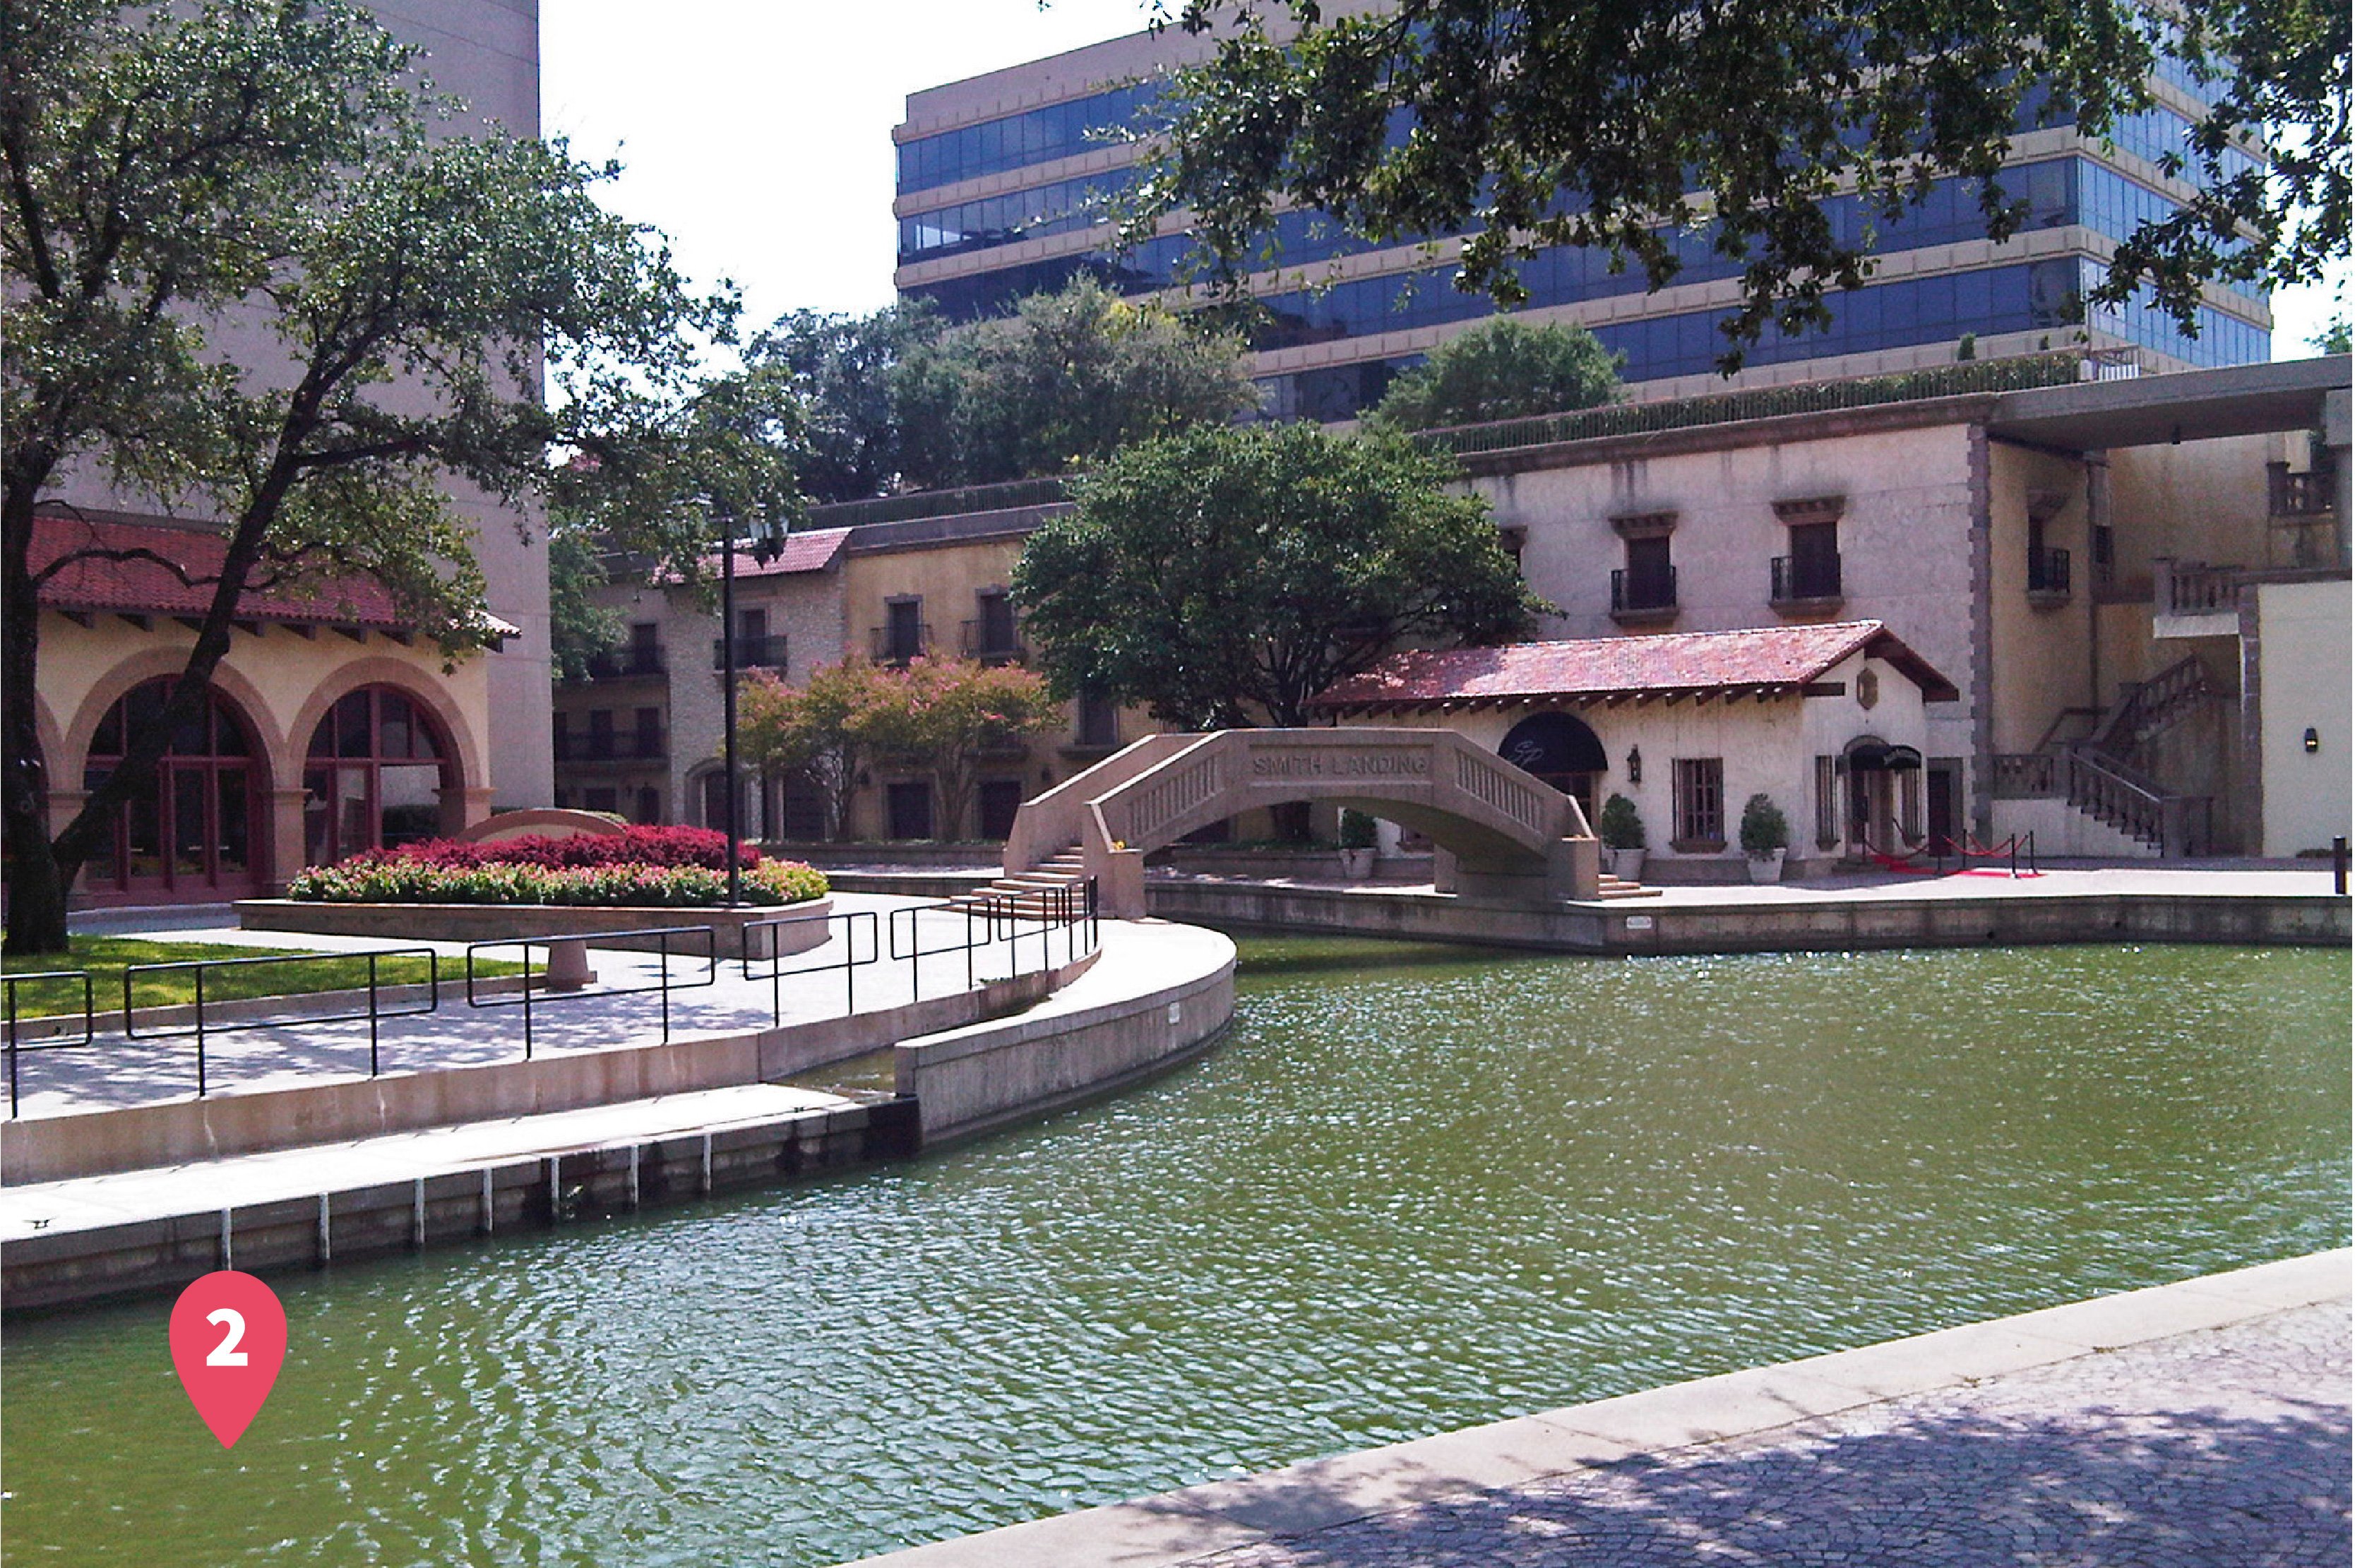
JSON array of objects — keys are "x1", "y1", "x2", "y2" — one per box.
[{"x1": 28, "y1": 515, "x2": 424, "y2": 631}]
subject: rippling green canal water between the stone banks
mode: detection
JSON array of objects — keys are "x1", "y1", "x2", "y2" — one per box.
[{"x1": 0, "y1": 940, "x2": 2348, "y2": 1568}]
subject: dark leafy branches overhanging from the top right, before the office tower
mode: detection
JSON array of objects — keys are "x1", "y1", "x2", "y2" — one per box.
[{"x1": 1123, "y1": 0, "x2": 2350, "y2": 370}]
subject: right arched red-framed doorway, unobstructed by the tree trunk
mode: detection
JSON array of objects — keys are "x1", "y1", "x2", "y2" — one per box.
[{"x1": 302, "y1": 685, "x2": 457, "y2": 866}]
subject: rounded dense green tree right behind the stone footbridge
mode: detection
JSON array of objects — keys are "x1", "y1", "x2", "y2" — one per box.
[{"x1": 1013, "y1": 424, "x2": 1545, "y2": 730}]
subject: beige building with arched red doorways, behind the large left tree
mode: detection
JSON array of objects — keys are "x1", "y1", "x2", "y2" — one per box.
[{"x1": 33, "y1": 0, "x2": 554, "y2": 904}]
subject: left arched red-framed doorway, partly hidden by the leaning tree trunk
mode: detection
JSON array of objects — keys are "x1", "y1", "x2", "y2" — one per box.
[{"x1": 83, "y1": 676, "x2": 268, "y2": 902}]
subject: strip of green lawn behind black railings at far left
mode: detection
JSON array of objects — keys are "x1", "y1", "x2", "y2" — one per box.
[{"x1": 0, "y1": 937, "x2": 523, "y2": 1017}]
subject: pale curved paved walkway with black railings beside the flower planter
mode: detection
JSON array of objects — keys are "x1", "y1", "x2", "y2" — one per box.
[{"x1": 19, "y1": 892, "x2": 1067, "y2": 1118}]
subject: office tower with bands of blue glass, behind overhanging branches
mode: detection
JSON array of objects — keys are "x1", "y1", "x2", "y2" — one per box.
[{"x1": 893, "y1": 30, "x2": 2272, "y2": 419}]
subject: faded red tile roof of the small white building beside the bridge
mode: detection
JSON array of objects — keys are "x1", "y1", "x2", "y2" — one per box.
[{"x1": 1314, "y1": 621, "x2": 1960, "y2": 711}]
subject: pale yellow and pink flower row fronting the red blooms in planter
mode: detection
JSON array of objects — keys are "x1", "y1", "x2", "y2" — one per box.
[{"x1": 287, "y1": 829, "x2": 827, "y2": 909}]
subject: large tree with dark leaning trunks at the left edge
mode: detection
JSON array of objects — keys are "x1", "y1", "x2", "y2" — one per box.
[{"x1": 0, "y1": 0, "x2": 730, "y2": 951}]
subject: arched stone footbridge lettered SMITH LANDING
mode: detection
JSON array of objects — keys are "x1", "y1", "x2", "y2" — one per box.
[{"x1": 1006, "y1": 730, "x2": 1599, "y2": 918}]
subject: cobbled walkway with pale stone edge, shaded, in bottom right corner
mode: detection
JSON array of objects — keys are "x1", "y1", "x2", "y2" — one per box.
[{"x1": 871, "y1": 1250, "x2": 2350, "y2": 1568}]
